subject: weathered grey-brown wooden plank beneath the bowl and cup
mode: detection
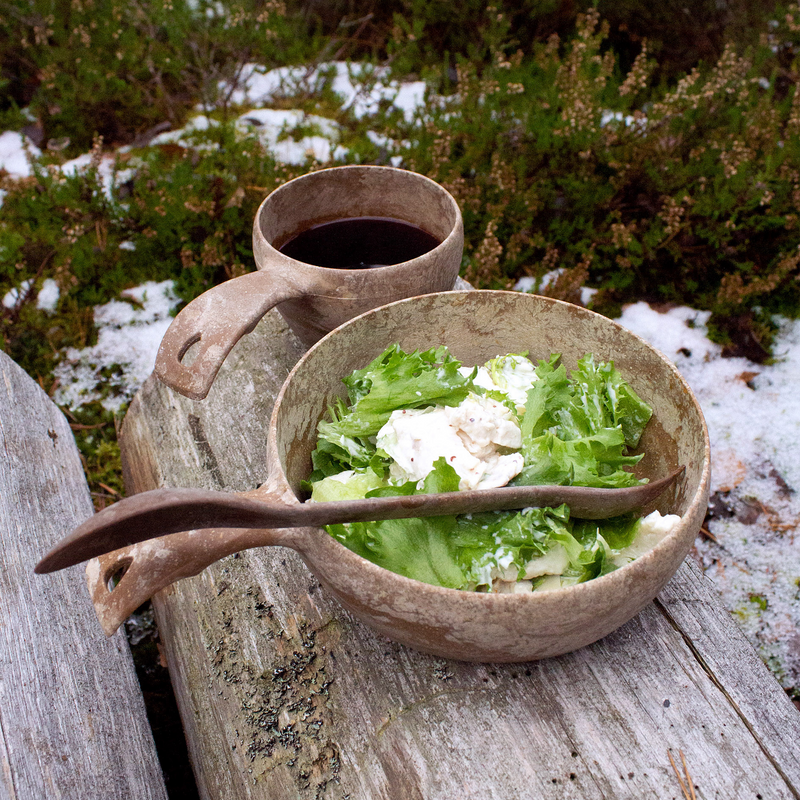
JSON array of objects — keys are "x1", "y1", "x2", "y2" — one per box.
[{"x1": 117, "y1": 313, "x2": 800, "y2": 800}]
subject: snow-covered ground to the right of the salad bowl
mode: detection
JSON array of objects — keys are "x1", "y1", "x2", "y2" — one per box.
[{"x1": 618, "y1": 303, "x2": 800, "y2": 687}]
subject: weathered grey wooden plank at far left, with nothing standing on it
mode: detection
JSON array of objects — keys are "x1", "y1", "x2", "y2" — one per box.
[{"x1": 0, "y1": 352, "x2": 166, "y2": 800}]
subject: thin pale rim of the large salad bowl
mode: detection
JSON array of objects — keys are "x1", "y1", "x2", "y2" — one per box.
[{"x1": 270, "y1": 289, "x2": 711, "y2": 608}]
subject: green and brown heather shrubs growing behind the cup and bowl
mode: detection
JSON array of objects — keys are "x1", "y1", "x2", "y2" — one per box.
[{"x1": 0, "y1": 0, "x2": 800, "y2": 506}]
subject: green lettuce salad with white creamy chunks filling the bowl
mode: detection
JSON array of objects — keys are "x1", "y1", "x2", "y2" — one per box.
[{"x1": 305, "y1": 345, "x2": 680, "y2": 593}]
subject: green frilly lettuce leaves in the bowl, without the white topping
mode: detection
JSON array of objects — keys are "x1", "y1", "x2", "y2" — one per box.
[{"x1": 310, "y1": 345, "x2": 652, "y2": 590}]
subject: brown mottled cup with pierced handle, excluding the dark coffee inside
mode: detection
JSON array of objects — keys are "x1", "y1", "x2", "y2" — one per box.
[{"x1": 155, "y1": 166, "x2": 464, "y2": 400}]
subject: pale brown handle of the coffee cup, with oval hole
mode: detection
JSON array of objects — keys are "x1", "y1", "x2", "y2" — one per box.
[{"x1": 155, "y1": 270, "x2": 309, "y2": 400}]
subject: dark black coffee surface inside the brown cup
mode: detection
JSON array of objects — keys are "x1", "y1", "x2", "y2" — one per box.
[{"x1": 278, "y1": 217, "x2": 440, "y2": 269}]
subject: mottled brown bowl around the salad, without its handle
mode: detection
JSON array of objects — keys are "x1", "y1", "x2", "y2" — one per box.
[{"x1": 268, "y1": 291, "x2": 709, "y2": 662}]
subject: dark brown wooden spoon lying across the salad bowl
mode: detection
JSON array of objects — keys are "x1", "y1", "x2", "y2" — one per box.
[{"x1": 35, "y1": 467, "x2": 684, "y2": 574}]
